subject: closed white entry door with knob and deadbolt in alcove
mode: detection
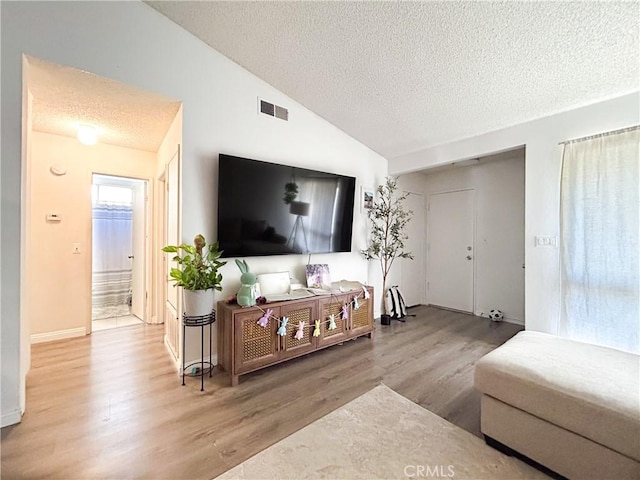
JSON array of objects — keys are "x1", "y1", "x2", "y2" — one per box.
[{"x1": 427, "y1": 190, "x2": 475, "y2": 312}]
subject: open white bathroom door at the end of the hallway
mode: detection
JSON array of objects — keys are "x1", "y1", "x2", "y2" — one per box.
[{"x1": 131, "y1": 180, "x2": 147, "y2": 321}]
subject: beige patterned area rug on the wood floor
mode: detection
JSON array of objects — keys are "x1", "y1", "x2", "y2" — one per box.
[{"x1": 217, "y1": 385, "x2": 549, "y2": 480}]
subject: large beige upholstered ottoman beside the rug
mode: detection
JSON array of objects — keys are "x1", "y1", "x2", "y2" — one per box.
[{"x1": 474, "y1": 331, "x2": 640, "y2": 480}]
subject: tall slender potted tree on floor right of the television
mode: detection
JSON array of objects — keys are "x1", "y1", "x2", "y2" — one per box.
[{"x1": 361, "y1": 177, "x2": 413, "y2": 325}]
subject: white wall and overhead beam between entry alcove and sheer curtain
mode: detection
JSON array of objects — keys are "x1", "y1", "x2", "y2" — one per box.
[{"x1": 389, "y1": 92, "x2": 640, "y2": 334}]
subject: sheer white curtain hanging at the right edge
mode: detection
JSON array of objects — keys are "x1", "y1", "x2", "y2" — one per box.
[{"x1": 559, "y1": 128, "x2": 640, "y2": 352}]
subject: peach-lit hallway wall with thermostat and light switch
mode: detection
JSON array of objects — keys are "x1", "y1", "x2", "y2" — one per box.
[{"x1": 24, "y1": 132, "x2": 156, "y2": 342}]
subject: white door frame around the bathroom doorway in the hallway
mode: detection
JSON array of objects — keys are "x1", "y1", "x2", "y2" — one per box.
[{"x1": 86, "y1": 169, "x2": 154, "y2": 335}]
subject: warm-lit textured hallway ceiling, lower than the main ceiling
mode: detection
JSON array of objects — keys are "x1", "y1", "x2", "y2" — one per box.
[{"x1": 27, "y1": 57, "x2": 180, "y2": 152}]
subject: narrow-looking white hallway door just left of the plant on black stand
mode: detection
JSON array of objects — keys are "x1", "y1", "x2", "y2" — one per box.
[{"x1": 163, "y1": 151, "x2": 181, "y2": 359}]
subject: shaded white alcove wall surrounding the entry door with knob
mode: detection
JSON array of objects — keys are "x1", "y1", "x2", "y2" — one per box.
[{"x1": 400, "y1": 149, "x2": 525, "y2": 324}]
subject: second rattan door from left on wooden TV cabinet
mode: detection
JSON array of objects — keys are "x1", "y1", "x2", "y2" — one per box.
[{"x1": 279, "y1": 299, "x2": 318, "y2": 359}]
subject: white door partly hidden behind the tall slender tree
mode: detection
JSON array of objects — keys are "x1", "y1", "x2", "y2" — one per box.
[{"x1": 400, "y1": 192, "x2": 427, "y2": 306}]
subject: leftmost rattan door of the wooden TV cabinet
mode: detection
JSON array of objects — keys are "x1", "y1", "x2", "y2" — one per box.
[{"x1": 233, "y1": 308, "x2": 280, "y2": 374}]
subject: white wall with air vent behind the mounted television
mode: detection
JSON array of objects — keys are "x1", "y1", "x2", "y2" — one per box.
[{"x1": 0, "y1": 2, "x2": 387, "y2": 424}]
